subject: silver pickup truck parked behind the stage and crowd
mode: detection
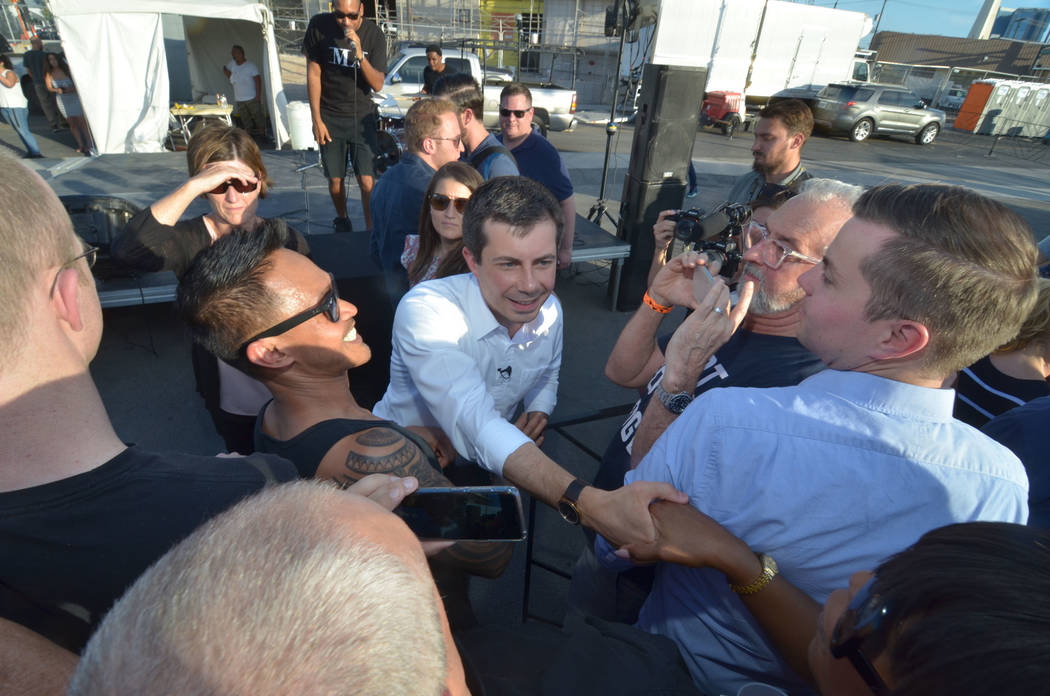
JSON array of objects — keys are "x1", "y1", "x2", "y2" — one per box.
[{"x1": 376, "y1": 46, "x2": 576, "y2": 134}]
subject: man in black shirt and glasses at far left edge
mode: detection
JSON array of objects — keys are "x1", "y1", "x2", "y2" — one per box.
[{"x1": 0, "y1": 159, "x2": 296, "y2": 655}]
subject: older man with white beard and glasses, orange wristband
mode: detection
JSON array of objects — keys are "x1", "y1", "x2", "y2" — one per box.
[{"x1": 570, "y1": 178, "x2": 862, "y2": 621}]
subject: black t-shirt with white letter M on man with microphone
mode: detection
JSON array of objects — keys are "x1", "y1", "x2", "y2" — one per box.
[{"x1": 302, "y1": 13, "x2": 386, "y2": 117}]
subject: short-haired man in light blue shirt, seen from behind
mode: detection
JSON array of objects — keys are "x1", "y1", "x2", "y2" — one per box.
[{"x1": 596, "y1": 185, "x2": 1036, "y2": 694}]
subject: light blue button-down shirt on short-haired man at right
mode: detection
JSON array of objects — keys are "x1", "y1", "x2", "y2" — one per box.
[{"x1": 596, "y1": 370, "x2": 1028, "y2": 694}]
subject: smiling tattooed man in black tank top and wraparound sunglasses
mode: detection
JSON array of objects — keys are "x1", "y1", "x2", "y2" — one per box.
[{"x1": 177, "y1": 225, "x2": 512, "y2": 625}]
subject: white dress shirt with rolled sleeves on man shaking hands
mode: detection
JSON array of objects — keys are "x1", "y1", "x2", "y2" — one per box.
[{"x1": 373, "y1": 273, "x2": 562, "y2": 473}]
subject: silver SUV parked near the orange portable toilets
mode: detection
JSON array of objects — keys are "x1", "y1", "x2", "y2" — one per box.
[{"x1": 813, "y1": 82, "x2": 944, "y2": 145}]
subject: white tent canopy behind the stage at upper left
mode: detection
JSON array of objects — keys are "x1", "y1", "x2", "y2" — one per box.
[{"x1": 50, "y1": 0, "x2": 288, "y2": 153}]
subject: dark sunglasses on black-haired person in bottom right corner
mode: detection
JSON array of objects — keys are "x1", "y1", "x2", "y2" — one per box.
[{"x1": 831, "y1": 576, "x2": 889, "y2": 696}]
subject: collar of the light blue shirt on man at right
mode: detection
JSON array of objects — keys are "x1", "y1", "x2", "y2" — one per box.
[{"x1": 802, "y1": 368, "x2": 956, "y2": 421}]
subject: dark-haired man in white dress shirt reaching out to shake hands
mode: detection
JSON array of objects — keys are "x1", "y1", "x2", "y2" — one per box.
[{"x1": 373, "y1": 176, "x2": 687, "y2": 543}]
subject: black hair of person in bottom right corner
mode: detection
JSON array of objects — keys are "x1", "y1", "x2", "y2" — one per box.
[{"x1": 873, "y1": 522, "x2": 1050, "y2": 696}]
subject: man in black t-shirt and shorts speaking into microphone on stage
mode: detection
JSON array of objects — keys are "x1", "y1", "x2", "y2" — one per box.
[{"x1": 302, "y1": 0, "x2": 386, "y2": 232}]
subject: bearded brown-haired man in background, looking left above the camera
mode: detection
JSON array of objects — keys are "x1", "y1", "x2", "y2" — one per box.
[{"x1": 727, "y1": 99, "x2": 813, "y2": 203}]
